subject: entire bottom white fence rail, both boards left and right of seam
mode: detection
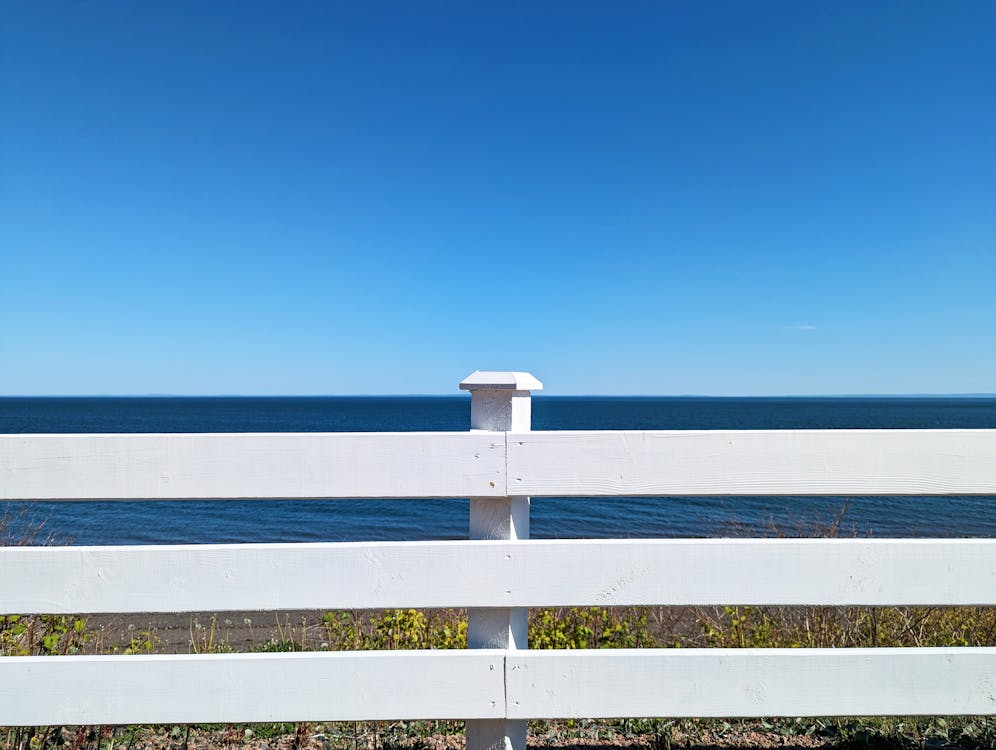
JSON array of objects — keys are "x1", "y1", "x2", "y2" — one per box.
[{"x1": 0, "y1": 648, "x2": 996, "y2": 725}]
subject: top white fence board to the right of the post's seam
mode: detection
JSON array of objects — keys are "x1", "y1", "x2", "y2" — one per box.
[{"x1": 508, "y1": 430, "x2": 996, "y2": 497}]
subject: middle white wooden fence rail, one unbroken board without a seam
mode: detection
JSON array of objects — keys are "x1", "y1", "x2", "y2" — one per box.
[{"x1": 0, "y1": 539, "x2": 996, "y2": 616}]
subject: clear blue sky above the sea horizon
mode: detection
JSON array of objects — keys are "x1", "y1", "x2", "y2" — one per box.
[{"x1": 0, "y1": 0, "x2": 996, "y2": 395}]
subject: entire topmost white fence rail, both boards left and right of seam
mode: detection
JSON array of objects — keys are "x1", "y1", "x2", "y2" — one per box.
[{"x1": 0, "y1": 430, "x2": 996, "y2": 500}]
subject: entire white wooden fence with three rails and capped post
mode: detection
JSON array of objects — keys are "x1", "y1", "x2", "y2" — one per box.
[{"x1": 0, "y1": 372, "x2": 996, "y2": 749}]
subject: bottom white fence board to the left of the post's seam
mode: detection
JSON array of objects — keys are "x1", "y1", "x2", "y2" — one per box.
[{"x1": 0, "y1": 651, "x2": 505, "y2": 726}]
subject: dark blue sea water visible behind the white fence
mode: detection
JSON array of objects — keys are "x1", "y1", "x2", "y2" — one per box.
[{"x1": 0, "y1": 396, "x2": 996, "y2": 544}]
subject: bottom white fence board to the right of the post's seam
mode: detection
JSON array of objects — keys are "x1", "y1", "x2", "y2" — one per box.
[{"x1": 506, "y1": 648, "x2": 996, "y2": 719}]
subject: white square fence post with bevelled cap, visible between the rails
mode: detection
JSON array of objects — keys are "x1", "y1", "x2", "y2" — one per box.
[{"x1": 460, "y1": 370, "x2": 543, "y2": 750}]
